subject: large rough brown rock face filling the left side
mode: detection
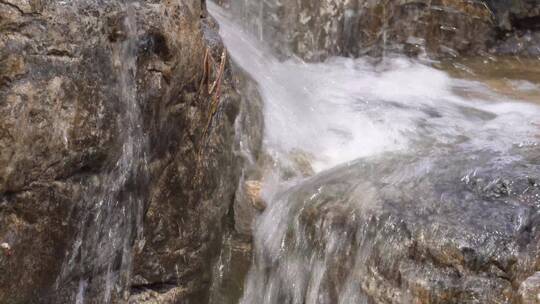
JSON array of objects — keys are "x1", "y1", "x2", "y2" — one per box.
[{"x1": 0, "y1": 0, "x2": 246, "y2": 304}]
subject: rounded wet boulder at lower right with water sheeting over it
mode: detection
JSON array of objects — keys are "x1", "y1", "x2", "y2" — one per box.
[{"x1": 242, "y1": 148, "x2": 540, "y2": 303}]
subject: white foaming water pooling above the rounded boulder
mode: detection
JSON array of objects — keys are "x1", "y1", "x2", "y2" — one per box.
[{"x1": 209, "y1": 3, "x2": 540, "y2": 172}]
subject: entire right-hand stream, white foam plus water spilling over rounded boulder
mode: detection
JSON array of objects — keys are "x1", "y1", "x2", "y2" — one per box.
[{"x1": 209, "y1": 5, "x2": 540, "y2": 304}]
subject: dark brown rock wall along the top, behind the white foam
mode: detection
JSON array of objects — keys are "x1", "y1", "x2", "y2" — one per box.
[{"x1": 222, "y1": 0, "x2": 540, "y2": 61}]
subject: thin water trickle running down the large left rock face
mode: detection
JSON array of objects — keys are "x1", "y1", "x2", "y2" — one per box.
[{"x1": 56, "y1": 0, "x2": 147, "y2": 304}]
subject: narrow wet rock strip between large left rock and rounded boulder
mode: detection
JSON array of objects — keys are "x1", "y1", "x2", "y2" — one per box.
[{"x1": 204, "y1": 65, "x2": 266, "y2": 304}]
